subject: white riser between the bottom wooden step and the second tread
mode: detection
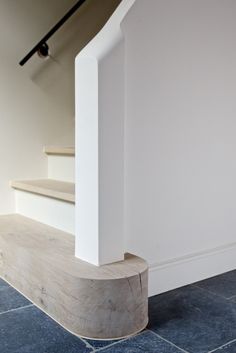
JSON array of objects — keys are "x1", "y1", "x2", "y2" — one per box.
[{"x1": 15, "y1": 190, "x2": 75, "y2": 234}]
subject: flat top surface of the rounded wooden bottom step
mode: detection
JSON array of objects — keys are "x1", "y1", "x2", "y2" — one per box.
[{"x1": 0, "y1": 214, "x2": 147, "y2": 280}]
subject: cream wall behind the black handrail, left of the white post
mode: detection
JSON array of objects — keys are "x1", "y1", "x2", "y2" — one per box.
[{"x1": 0, "y1": 0, "x2": 120, "y2": 214}]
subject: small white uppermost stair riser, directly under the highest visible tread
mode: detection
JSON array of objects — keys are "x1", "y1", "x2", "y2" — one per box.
[{"x1": 48, "y1": 155, "x2": 75, "y2": 183}]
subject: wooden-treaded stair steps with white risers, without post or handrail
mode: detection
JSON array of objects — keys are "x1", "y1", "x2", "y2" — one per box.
[{"x1": 0, "y1": 147, "x2": 148, "y2": 339}]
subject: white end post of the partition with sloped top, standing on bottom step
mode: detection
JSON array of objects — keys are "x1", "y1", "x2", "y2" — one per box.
[{"x1": 76, "y1": 0, "x2": 135, "y2": 265}]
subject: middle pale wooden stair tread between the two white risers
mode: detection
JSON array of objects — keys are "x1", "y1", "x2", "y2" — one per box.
[{"x1": 10, "y1": 179, "x2": 75, "y2": 203}]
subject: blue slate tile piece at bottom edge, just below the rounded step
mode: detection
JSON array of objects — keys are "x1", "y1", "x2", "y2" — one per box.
[{"x1": 97, "y1": 331, "x2": 182, "y2": 353}]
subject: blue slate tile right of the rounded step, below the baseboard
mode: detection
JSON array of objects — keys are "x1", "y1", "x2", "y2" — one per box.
[{"x1": 149, "y1": 286, "x2": 236, "y2": 353}]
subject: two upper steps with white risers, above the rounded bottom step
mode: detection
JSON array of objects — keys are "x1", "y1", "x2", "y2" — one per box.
[{"x1": 10, "y1": 147, "x2": 75, "y2": 234}]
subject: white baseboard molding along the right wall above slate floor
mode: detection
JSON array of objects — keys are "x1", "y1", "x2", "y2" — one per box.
[{"x1": 149, "y1": 242, "x2": 236, "y2": 296}]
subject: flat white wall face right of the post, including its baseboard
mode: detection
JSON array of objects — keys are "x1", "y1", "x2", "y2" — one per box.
[{"x1": 122, "y1": 0, "x2": 236, "y2": 294}]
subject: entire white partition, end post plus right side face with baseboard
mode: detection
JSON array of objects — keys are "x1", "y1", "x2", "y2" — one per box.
[{"x1": 76, "y1": 0, "x2": 236, "y2": 294}]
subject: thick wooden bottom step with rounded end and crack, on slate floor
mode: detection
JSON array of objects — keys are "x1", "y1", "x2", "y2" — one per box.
[{"x1": 0, "y1": 215, "x2": 148, "y2": 339}]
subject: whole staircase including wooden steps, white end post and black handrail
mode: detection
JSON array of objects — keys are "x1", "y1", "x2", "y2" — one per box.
[{"x1": 0, "y1": 0, "x2": 148, "y2": 339}]
